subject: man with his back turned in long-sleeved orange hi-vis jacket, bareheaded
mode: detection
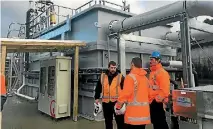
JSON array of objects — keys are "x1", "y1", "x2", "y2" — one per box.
[{"x1": 115, "y1": 57, "x2": 151, "y2": 129}]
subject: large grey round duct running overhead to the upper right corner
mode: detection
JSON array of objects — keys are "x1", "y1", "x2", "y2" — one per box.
[{"x1": 109, "y1": 0, "x2": 213, "y2": 33}]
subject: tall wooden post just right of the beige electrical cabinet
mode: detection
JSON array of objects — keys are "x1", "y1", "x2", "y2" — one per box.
[{"x1": 73, "y1": 47, "x2": 79, "y2": 121}]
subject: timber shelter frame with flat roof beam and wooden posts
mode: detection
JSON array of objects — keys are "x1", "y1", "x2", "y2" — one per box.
[{"x1": 0, "y1": 38, "x2": 86, "y2": 121}]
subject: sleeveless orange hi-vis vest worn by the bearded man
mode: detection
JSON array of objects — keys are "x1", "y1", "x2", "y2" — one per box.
[{"x1": 101, "y1": 73, "x2": 122, "y2": 103}]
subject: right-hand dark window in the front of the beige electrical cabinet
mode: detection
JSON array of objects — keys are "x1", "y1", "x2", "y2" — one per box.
[{"x1": 47, "y1": 66, "x2": 55, "y2": 96}]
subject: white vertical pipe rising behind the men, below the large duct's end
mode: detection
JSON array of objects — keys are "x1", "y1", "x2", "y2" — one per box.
[{"x1": 118, "y1": 34, "x2": 126, "y2": 76}]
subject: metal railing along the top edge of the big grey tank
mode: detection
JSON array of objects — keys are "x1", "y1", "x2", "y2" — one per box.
[{"x1": 28, "y1": 0, "x2": 128, "y2": 37}]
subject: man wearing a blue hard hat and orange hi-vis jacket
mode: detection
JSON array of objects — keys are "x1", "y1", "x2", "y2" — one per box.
[{"x1": 149, "y1": 51, "x2": 170, "y2": 129}]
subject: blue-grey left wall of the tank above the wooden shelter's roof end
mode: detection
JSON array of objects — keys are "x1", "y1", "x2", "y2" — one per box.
[{"x1": 68, "y1": 11, "x2": 98, "y2": 42}]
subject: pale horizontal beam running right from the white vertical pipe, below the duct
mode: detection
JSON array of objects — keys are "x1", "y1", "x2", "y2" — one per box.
[{"x1": 123, "y1": 34, "x2": 181, "y2": 48}]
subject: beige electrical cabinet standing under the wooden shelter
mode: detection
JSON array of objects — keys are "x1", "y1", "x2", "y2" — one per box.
[{"x1": 38, "y1": 56, "x2": 71, "y2": 119}]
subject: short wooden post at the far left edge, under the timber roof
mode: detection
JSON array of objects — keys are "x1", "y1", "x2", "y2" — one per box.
[{"x1": 0, "y1": 46, "x2": 7, "y2": 75}]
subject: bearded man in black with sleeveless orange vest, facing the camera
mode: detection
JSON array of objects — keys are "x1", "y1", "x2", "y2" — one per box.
[{"x1": 94, "y1": 61, "x2": 124, "y2": 129}]
